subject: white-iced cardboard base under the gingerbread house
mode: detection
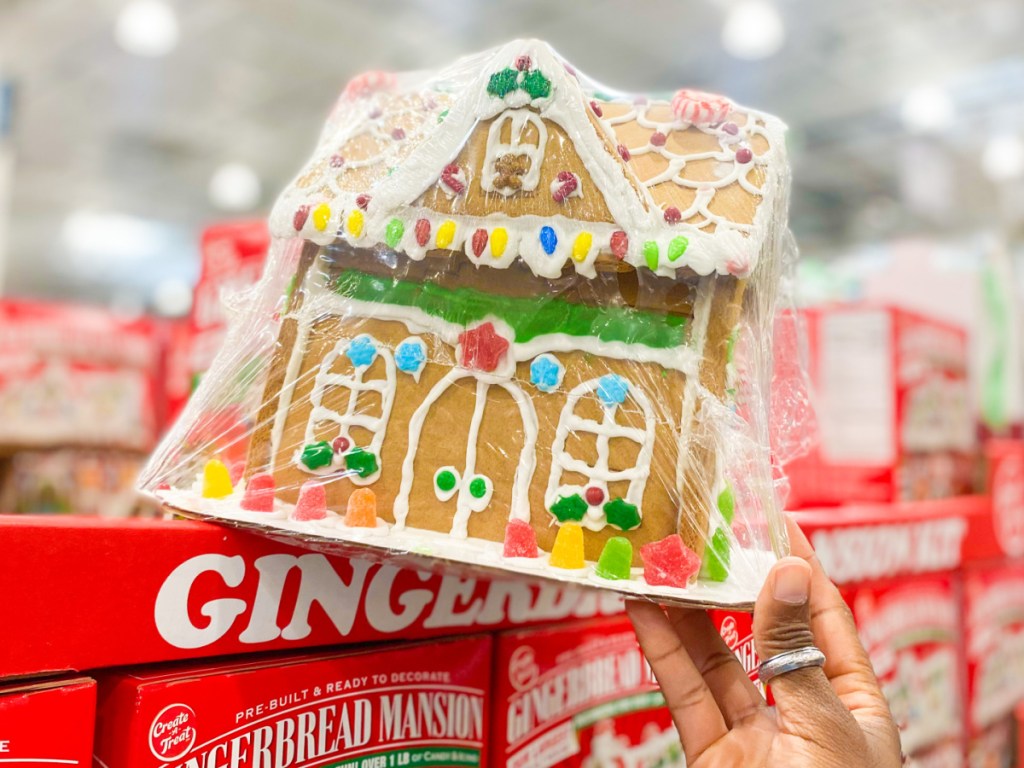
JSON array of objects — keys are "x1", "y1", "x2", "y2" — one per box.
[{"x1": 154, "y1": 489, "x2": 776, "y2": 612}]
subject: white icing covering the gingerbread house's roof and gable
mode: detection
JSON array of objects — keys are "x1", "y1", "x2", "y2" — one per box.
[{"x1": 271, "y1": 41, "x2": 785, "y2": 278}]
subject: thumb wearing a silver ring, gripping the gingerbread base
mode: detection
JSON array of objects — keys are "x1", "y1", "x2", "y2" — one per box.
[{"x1": 754, "y1": 557, "x2": 856, "y2": 743}]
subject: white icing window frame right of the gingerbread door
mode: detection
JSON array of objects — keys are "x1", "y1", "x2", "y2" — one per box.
[{"x1": 544, "y1": 378, "x2": 654, "y2": 530}]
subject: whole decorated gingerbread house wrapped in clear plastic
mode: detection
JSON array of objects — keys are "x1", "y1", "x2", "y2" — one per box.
[{"x1": 142, "y1": 41, "x2": 795, "y2": 606}]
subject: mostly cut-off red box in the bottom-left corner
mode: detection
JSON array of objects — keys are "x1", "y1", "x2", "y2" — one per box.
[{"x1": 0, "y1": 678, "x2": 96, "y2": 768}]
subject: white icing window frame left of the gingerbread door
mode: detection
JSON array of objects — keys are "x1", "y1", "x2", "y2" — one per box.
[{"x1": 296, "y1": 334, "x2": 397, "y2": 485}]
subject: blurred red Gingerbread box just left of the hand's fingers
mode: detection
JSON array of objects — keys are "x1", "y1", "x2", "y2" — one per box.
[{"x1": 490, "y1": 617, "x2": 683, "y2": 768}]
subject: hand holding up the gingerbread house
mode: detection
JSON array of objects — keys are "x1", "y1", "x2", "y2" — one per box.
[{"x1": 627, "y1": 519, "x2": 901, "y2": 768}]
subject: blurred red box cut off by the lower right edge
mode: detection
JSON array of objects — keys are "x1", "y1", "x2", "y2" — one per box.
[{"x1": 964, "y1": 563, "x2": 1024, "y2": 737}]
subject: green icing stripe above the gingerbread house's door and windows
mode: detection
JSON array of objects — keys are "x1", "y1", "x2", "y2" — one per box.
[{"x1": 335, "y1": 269, "x2": 686, "y2": 349}]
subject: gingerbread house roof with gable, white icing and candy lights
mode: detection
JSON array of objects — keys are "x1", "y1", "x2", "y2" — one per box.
[{"x1": 271, "y1": 40, "x2": 788, "y2": 278}]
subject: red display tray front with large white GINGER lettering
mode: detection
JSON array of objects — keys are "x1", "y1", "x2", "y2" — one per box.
[{"x1": 0, "y1": 515, "x2": 622, "y2": 677}]
